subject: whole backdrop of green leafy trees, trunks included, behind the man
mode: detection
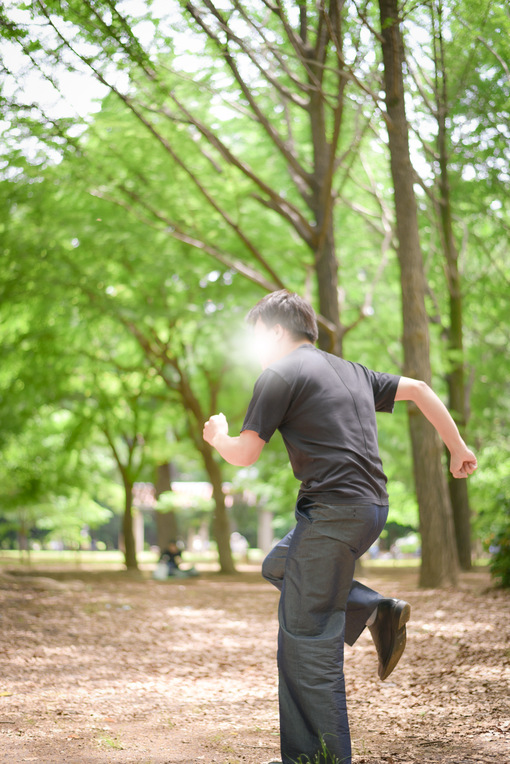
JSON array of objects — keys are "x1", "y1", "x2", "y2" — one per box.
[{"x1": 0, "y1": 0, "x2": 510, "y2": 585}]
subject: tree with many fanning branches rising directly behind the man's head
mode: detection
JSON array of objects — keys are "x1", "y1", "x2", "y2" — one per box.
[{"x1": 2, "y1": 2, "x2": 506, "y2": 584}]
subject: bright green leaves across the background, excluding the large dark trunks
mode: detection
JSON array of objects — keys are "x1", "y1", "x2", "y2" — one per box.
[{"x1": 0, "y1": 0, "x2": 510, "y2": 564}]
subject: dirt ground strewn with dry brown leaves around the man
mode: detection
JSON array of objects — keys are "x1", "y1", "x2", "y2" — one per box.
[{"x1": 0, "y1": 569, "x2": 510, "y2": 764}]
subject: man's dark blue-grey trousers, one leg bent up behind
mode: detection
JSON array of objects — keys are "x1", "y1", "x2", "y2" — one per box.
[{"x1": 262, "y1": 500, "x2": 388, "y2": 764}]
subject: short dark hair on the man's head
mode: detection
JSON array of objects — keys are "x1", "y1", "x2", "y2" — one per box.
[{"x1": 246, "y1": 289, "x2": 319, "y2": 342}]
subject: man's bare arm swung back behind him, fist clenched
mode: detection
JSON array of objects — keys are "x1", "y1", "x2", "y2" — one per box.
[{"x1": 395, "y1": 377, "x2": 478, "y2": 478}]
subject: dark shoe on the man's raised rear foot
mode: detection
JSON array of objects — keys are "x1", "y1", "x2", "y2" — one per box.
[{"x1": 368, "y1": 599, "x2": 411, "y2": 680}]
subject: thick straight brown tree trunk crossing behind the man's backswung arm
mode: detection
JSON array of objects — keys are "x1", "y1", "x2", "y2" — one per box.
[{"x1": 379, "y1": 0, "x2": 458, "y2": 587}]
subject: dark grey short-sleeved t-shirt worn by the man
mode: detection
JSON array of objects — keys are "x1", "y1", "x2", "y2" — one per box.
[{"x1": 242, "y1": 344, "x2": 400, "y2": 505}]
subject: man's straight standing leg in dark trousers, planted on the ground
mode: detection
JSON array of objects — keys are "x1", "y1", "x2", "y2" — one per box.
[{"x1": 273, "y1": 518, "x2": 355, "y2": 764}]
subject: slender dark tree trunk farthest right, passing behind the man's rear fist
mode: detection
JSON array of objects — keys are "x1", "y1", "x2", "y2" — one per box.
[{"x1": 435, "y1": 7, "x2": 471, "y2": 570}]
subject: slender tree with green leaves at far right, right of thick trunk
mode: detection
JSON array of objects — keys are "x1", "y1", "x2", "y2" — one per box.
[{"x1": 406, "y1": 0, "x2": 510, "y2": 570}]
